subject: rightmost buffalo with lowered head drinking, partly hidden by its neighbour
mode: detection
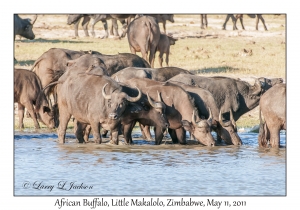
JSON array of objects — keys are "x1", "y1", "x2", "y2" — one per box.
[{"x1": 172, "y1": 82, "x2": 242, "y2": 145}]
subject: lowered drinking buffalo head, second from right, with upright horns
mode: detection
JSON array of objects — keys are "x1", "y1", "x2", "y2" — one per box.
[{"x1": 182, "y1": 109, "x2": 216, "y2": 146}]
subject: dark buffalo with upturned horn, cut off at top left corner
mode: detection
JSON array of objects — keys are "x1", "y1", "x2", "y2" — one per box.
[{"x1": 14, "y1": 14, "x2": 37, "y2": 39}]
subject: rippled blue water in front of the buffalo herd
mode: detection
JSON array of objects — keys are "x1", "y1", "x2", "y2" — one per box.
[{"x1": 14, "y1": 132, "x2": 286, "y2": 196}]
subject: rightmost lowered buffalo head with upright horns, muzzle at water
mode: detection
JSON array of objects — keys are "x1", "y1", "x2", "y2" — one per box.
[{"x1": 217, "y1": 110, "x2": 242, "y2": 145}]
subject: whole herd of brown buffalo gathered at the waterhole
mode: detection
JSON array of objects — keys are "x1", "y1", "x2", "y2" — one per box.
[{"x1": 14, "y1": 15, "x2": 286, "y2": 147}]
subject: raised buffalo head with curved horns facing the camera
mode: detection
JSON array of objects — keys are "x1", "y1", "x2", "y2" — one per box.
[{"x1": 102, "y1": 83, "x2": 142, "y2": 120}]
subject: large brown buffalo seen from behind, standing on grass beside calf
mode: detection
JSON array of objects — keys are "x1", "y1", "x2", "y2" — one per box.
[{"x1": 127, "y1": 16, "x2": 160, "y2": 68}]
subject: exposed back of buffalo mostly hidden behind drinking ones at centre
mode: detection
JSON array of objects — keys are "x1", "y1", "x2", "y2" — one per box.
[{"x1": 111, "y1": 67, "x2": 192, "y2": 82}]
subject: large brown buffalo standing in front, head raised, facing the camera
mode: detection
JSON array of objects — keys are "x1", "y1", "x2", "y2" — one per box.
[{"x1": 53, "y1": 73, "x2": 141, "y2": 144}]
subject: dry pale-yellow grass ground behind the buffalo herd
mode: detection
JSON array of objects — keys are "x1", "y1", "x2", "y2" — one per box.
[{"x1": 15, "y1": 14, "x2": 286, "y2": 130}]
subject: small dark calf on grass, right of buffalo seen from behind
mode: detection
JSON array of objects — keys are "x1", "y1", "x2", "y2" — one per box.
[{"x1": 156, "y1": 34, "x2": 177, "y2": 67}]
